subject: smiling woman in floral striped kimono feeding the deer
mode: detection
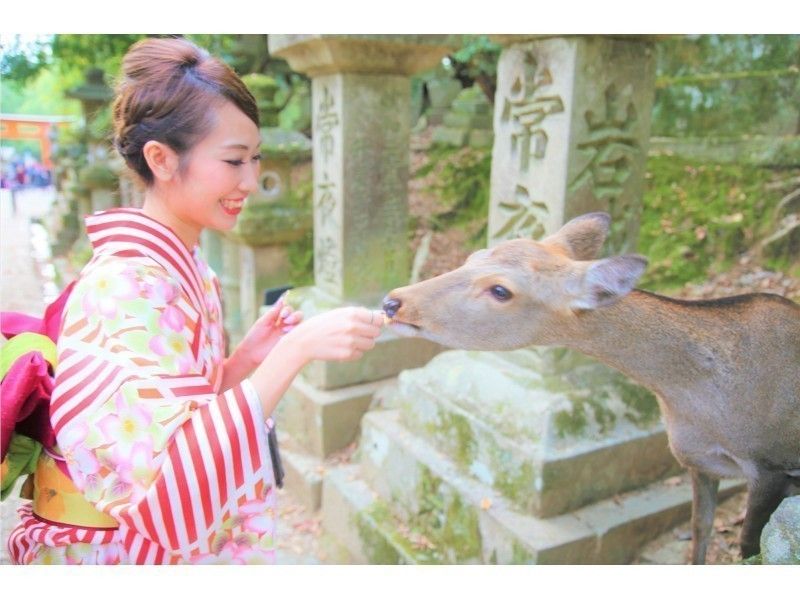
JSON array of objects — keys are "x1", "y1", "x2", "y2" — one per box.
[{"x1": 9, "y1": 39, "x2": 382, "y2": 564}]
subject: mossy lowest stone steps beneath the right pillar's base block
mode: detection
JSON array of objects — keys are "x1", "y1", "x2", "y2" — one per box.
[{"x1": 322, "y1": 410, "x2": 743, "y2": 564}]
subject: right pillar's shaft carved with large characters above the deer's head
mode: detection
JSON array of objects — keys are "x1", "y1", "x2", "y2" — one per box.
[{"x1": 489, "y1": 36, "x2": 655, "y2": 254}]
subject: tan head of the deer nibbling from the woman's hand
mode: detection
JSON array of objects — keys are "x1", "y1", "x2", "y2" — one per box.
[{"x1": 383, "y1": 212, "x2": 647, "y2": 350}]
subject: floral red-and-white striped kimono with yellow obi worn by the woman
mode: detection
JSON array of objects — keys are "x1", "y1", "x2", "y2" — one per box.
[{"x1": 8, "y1": 208, "x2": 275, "y2": 564}]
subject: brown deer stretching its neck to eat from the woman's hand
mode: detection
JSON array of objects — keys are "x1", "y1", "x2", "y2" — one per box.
[{"x1": 383, "y1": 212, "x2": 800, "y2": 564}]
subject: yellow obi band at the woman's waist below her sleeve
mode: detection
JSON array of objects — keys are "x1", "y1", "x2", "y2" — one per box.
[{"x1": 33, "y1": 453, "x2": 119, "y2": 529}]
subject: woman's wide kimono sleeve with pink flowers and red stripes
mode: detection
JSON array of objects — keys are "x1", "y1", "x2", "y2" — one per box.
[{"x1": 51, "y1": 260, "x2": 274, "y2": 562}]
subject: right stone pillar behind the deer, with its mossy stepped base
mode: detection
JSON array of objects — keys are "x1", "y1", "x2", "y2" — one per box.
[{"x1": 323, "y1": 36, "x2": 712, "y2": 564}]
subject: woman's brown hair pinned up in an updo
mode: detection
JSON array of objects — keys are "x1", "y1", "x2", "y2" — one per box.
[{"x1": 113, "y1": 38, "x2": 259, "y2": 185}]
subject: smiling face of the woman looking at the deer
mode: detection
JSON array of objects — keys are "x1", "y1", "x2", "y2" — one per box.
[{"x1": 161, "y1": 102, "x2": 261, "y2": 247}]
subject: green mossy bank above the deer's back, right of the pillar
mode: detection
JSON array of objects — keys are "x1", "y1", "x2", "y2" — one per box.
[{"x1": 639, "y1": 156, "x2": 792, "y2": 289}]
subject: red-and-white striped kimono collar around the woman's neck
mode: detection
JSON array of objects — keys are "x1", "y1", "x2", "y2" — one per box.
[{"x1": 85, "y1": 208, "x2": 205, "y2": 314}]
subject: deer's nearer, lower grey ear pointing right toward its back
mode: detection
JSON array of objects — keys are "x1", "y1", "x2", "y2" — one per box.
[{"x1": 571, "y1": 255, "x2": 647, "y2": 309}]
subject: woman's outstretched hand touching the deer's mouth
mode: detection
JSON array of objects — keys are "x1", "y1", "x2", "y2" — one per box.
[{"x1": 285, "y1": 307, "x2": 383, "y2": 361}]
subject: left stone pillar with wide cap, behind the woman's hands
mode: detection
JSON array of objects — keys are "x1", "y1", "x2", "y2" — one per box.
[{"x1": 269, "y1": 35, "x2": 450, "y2": 505}]
